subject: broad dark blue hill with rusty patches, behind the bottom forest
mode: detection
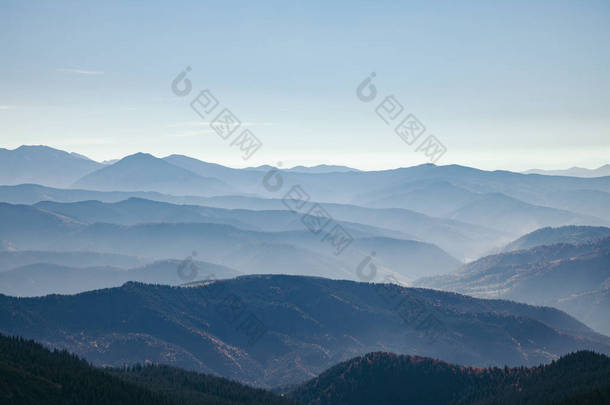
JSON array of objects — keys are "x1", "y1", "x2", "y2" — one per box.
[{"x1": 0, "y1": 275, "x2": 610, "y2": 386}]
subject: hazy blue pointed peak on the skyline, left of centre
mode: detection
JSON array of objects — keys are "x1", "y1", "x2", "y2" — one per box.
[{"x1": 73, "y1": 153, "x2": 230, "y2": 195}]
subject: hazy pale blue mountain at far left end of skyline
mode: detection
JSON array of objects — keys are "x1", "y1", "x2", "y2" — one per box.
[{"x1": 0, "y1": 145, "x2": 102, "y2": 187}]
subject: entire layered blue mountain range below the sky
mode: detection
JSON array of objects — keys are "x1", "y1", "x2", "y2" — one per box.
[{"x1": 0, "y1": 146, "x2": 610, "y2": 398}]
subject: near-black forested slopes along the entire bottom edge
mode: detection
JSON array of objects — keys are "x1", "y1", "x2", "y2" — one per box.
[{"x1": 0, "y1": 335, "x2": 610, "y2": 405}]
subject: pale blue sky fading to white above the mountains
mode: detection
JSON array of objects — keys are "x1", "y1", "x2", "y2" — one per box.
[{"x1": 0, "y1": 0, "x2": 610, "y2": 170}]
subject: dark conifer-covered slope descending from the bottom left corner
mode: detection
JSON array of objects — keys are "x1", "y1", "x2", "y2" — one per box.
[{"x1": 0, "y1": 335, "x2": 292, "y2": 405}]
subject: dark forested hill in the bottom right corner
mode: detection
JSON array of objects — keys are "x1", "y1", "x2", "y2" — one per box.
[{"x1": 290, "y1": 351, "x2": 610, "y2": 405}]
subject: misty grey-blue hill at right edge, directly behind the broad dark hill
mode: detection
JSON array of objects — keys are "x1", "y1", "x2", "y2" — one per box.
[{"x1": 415, "y1": 237, "x2": 610, "y2": 334}]
